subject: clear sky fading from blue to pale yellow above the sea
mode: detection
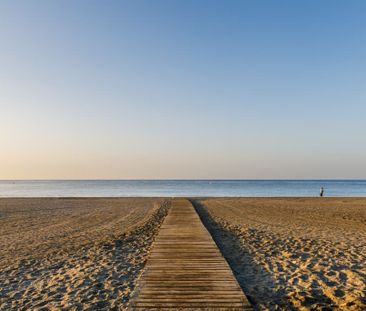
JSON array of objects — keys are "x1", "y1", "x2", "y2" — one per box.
[{"x1": 0, "y1": 0, "x2": 366, "y2": 179}]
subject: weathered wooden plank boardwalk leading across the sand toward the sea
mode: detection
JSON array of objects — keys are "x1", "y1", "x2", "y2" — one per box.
[{"x1": 130, "y1": 199, "x2": 252, "y2": 310}]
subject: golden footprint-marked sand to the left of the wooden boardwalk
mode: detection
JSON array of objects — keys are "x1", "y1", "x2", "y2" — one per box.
[{"x1": 0, "y1": 198, "x2": 169, "y2": 310}]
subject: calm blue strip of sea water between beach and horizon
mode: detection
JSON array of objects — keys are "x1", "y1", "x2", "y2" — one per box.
[{"x1": 0, "y1": 180, "x2": 366, "y2": 197}]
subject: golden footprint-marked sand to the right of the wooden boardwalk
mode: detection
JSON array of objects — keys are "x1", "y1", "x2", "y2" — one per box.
[{"x1": 193, "y1": 198, "x2": 366, "y2": 310}]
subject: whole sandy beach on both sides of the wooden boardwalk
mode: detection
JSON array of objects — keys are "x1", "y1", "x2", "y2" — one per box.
[{"x1": 0, "y1": 198, "x2": 366, "y2": 310}]
